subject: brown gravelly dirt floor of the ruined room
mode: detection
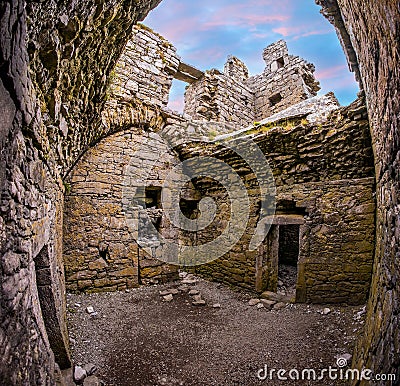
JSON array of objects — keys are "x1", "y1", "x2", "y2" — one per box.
[{"x1": 68, "y1": 280, "x2": 363, "y2": 386}]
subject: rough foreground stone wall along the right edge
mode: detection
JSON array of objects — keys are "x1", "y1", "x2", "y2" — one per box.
[{"x1": 318, "y1": 0, "x2": 400, "y2": 384}]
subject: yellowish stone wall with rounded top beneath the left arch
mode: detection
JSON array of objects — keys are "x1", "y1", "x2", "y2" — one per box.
[{"x1": 64, "y1": 129, "x2": 179, "y2": 292}]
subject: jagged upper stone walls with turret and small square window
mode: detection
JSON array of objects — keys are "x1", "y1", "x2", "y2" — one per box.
[{"x1": 184, "y1": 40, "x2": 320, "y2": 128}]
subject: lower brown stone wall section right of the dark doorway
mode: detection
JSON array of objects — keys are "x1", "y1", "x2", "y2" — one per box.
[{"x1": 278, "y1": 178, "x2": 375, "y2": 304}]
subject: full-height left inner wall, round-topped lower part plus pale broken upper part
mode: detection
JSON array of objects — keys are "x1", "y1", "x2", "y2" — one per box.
[{"x1": 64, "y1": 25, "x2": 227, "y2": 292}]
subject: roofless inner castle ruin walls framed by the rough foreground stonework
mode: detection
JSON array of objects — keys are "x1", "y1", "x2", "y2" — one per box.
[{"x1": 64, "y1": 25, "x2": 375, "y2": 304}]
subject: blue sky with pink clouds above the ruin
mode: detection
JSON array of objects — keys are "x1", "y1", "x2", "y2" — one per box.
[{"x1": 143, "y1": 0, "x2": 358, "y2": 111}]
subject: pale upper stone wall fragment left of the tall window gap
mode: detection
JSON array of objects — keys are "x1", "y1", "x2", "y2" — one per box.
[{"x1": 110, "y1": 24, "x2": 180, "y2": 106}]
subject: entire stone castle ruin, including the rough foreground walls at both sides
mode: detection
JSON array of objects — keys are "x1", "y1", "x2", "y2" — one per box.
[{"x1": 0, "y1": 0, "x2": 400, "y2": 385}]
